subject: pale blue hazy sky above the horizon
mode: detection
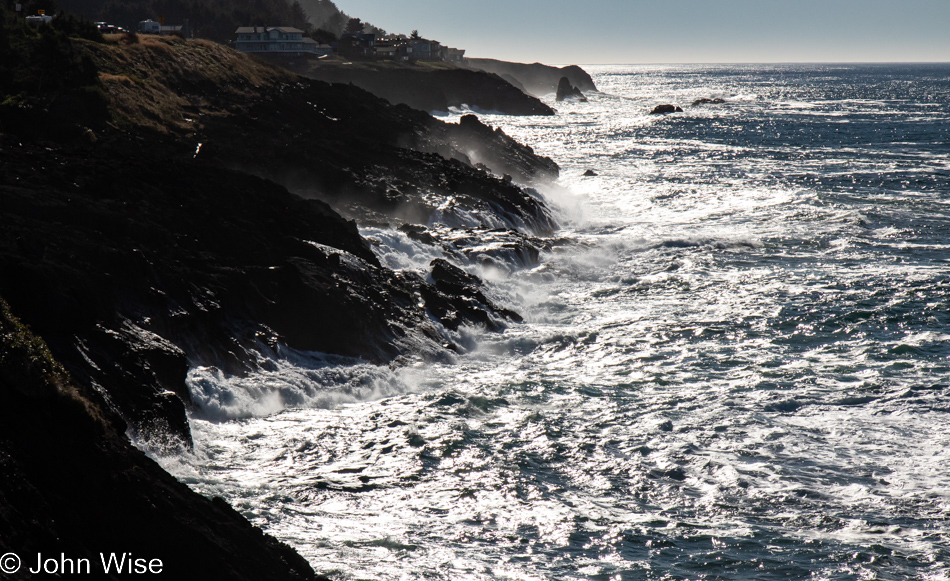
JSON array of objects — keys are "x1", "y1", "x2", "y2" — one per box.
[{"x1": 335, "y1": 0, "x2": 950, "y2": 64}]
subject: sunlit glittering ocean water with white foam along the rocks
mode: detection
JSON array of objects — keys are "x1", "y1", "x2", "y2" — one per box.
[{"x1": 161, "y1": 65, "x2": 950, "y2": 580}]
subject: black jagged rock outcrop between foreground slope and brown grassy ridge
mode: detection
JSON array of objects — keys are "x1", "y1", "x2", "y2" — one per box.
[{"x1": 0, "y1": 140, "x2": 532, "y2": 445}]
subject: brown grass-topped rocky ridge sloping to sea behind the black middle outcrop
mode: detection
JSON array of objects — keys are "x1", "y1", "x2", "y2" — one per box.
[{"x1": 85, "y1": 36, "x2": 558, "y2": 232}]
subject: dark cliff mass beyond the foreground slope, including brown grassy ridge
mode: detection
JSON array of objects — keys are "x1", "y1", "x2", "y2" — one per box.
[{"x1": 0, "y1": 36, "x2": 557, "y2": 445}]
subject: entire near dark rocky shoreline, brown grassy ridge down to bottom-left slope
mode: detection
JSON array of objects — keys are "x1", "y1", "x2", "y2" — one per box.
[{"x1": 0, "y1": 26, "x2": 572, "y2": 579}]
